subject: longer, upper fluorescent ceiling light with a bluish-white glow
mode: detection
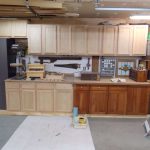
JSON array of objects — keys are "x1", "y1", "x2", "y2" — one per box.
[{"x1": 95, "y1": 7, "x2": 150, "y2": 11}]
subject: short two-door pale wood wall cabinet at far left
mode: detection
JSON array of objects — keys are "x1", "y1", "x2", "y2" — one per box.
[{"x1": 0, "y1": 20, "x2": 27, "y2": 38}]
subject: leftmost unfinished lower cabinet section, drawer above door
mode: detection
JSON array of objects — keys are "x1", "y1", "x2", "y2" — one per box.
[{"x1": 5, "y1": 82, "x2": 21, "y2": 111}]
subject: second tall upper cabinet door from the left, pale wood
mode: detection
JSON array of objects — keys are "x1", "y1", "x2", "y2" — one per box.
[{"x1": 42, "y1": 25, "x2": 57, "y2": 54}]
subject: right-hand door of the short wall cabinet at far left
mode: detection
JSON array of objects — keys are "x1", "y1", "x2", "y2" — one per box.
[{"x1": 12, "y1": 20, "x2": 27, "y2": 37}]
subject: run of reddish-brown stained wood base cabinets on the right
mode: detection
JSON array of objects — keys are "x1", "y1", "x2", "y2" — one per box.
[{"x1": 74, "y1": 85, "x2": 150, "y2": 115}]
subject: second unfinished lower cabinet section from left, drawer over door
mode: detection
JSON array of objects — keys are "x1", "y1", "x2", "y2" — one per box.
[{"x1": 21, "y1": 82, "x2": 36, "y2": 112}]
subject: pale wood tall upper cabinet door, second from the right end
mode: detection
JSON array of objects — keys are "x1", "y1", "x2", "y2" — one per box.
[{"x1": 117, "y1": 25, "x2": 133, "y2": 56}]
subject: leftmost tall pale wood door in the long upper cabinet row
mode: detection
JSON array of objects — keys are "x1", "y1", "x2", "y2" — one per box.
[{"x1": 27, "y1": 24, "x2": 42, "y2": 54}]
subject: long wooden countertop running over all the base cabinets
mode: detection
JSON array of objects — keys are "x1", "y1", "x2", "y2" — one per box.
[{"x1": 5, "y1": 76, "x2": 150, "y2": 86}]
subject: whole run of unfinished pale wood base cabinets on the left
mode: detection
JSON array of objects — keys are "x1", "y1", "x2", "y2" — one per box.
[{"x1": 6, "y1": 81, "x2": 73, "y2": 113}]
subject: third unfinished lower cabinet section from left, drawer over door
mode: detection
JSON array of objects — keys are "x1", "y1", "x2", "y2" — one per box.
[{"x1": 36, "y1": 83, "x2": 54, "y2": 112}]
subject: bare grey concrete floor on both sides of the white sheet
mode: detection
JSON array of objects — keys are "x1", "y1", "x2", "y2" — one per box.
[{"x1": 0, "y1": 116, "x2": 150, "y2": 150}]
